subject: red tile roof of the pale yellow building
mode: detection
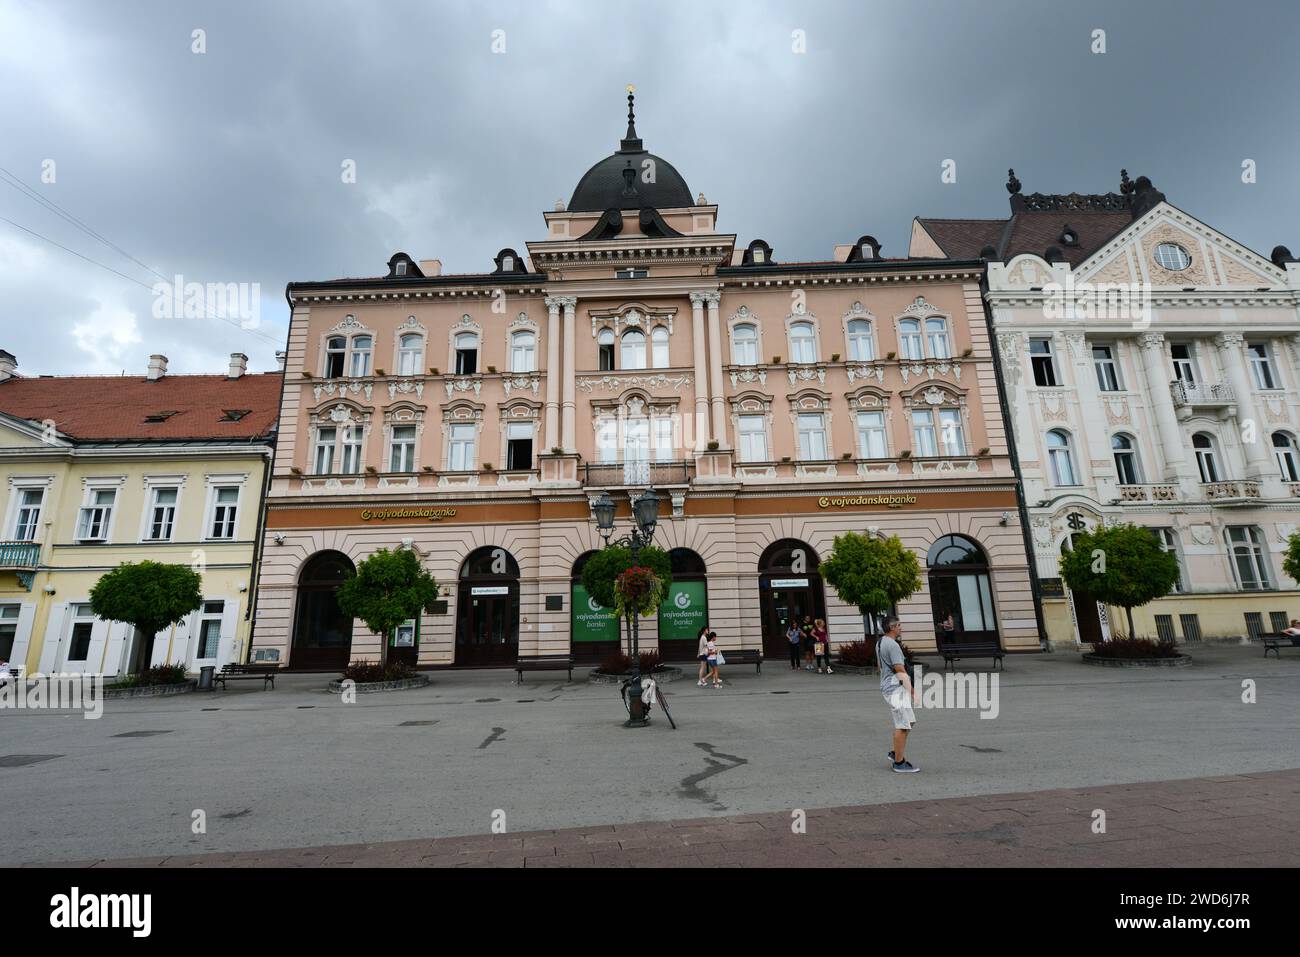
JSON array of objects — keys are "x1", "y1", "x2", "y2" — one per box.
[{"x1": 0, "y1": 372, "x2": 283, "y2": 442}]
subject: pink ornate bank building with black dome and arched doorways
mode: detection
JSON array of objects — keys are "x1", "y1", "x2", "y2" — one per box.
[{"x1": 254, "y1": 96, "x2": 1039, "y2": 668}]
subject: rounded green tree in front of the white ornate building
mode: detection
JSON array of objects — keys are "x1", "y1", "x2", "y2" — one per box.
[{"x1": 1061, "y1": 524, "x2": 1178, "y2": 638}]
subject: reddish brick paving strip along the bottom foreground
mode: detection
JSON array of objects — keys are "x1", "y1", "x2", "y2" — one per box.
[{"x1": 50, "y1": 768, "x2": 1300, "y2": 867}]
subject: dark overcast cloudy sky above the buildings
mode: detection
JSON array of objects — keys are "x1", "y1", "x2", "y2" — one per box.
[{"x1": 0, "y1": 0, "x2": 1300, "y2": 374}]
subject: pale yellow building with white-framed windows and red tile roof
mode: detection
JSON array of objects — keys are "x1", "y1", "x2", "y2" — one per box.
[{"x1": 0, "y1": 351, "x2": 282, "y2": 675}]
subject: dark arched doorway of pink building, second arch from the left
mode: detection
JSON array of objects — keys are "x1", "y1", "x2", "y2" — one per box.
[{"x1": 455, "y1": 546, "x2": 519, "y2": 667}]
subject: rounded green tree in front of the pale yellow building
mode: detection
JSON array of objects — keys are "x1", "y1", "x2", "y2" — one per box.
[{"x1": 90, "y1": 562, "x2": 203, "y2": 672}]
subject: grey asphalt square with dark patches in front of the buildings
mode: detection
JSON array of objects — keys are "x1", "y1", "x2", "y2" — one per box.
[{"x1": 0, "y1": 644, "x2": 1300, "y2": 865}]
